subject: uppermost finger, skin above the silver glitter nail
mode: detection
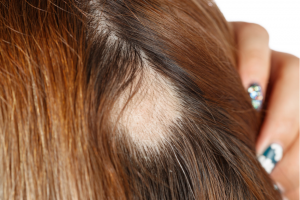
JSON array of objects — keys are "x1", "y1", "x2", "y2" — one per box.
[{"x1": 231, "y1": 22, "x2": 270, "y2": 108}]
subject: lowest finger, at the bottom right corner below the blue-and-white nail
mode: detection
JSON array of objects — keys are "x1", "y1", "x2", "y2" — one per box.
[{"x1": 271, "y1": 134, "x2": 299, "y2": 194}]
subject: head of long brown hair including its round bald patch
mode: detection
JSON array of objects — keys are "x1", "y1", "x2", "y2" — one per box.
[{"x1": 0, "y1": 0, "x2": 280, "y2": 200}]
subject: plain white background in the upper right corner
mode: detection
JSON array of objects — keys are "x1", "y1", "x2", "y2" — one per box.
[{"x1": 215, "y1": 0, "x2": 300, "y2": 57}]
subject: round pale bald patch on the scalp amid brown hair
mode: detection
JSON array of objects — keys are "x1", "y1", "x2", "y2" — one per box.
[{"x1": 111, "y1": 61, "x2": 181, "y2": 148}]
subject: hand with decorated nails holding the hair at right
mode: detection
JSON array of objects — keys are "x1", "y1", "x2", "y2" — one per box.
[{"x1": 231, "y1": 22, "x2": 299, "y2": 200}]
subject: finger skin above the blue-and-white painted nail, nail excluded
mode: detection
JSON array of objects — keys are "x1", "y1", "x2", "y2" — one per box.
[{"x1": 256, "y1": 51, "x2": 299, "y2": 170}]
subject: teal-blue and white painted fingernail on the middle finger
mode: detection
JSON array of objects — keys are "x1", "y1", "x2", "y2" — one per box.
[{"x1": 258, "y1": 143, "x2": 283, "y2": 174}]
